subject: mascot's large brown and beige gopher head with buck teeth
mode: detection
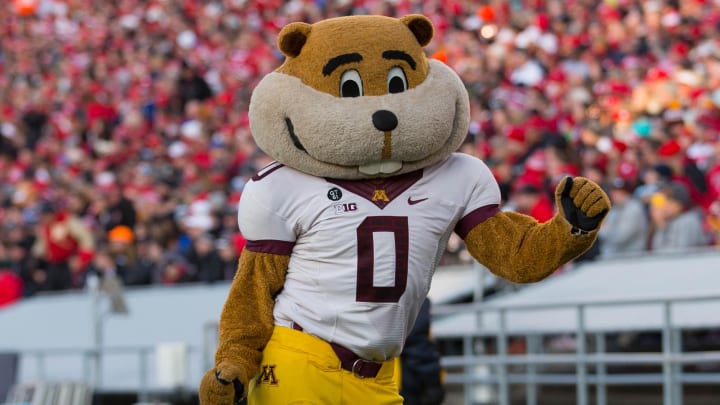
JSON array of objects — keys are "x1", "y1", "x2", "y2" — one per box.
[{"x1": 250, "y1": 15, "x2": 470, "y2": 179}]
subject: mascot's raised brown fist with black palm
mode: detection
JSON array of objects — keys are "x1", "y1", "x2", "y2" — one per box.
[{"x1": 555, "y1": 177, "x2": 610, "y2": 234}]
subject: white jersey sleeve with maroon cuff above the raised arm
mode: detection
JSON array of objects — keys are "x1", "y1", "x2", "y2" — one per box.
[{"x1": 455, "y1": 156, "x2": 500, "y2": 239}]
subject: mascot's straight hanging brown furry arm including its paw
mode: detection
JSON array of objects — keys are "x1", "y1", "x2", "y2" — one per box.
[{"x1": 200, "y1": 250, "x2": 290, "y2": 405}]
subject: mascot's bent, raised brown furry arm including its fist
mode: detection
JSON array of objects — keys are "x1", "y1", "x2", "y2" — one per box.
[{"x1": 465, "y1": 177, "x2": 610, "y2": 283}]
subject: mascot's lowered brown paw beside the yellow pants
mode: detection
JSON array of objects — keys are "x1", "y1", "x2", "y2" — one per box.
[{"x1": 199, "y1": 363, "x2": 245, "y2": 405}]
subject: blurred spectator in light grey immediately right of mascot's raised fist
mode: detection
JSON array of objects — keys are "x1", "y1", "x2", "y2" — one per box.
[{"x1": 598, "y1": 178, "x2": 649, "y2": 258}]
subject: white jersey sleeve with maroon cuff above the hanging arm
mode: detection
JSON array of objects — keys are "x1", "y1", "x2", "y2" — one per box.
[{"x1": 238, "y1": 163, "x2": 297, "y2": 255}]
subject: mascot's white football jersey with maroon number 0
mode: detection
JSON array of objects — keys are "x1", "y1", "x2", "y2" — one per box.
[{"x1": 238, "y1": 154, "x2": 500, "y2": 361}]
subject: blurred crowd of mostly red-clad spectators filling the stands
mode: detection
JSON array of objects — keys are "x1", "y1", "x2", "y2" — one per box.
[{"x1": 0, "y1": 0, "x2": 720, "y2": 305}]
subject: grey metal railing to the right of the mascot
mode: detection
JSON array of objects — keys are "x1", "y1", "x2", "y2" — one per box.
[{"x1": 433, "y1": 294, "x2": 720, "y2": 405}]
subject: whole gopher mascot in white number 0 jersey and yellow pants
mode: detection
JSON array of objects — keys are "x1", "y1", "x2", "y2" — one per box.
[{"x1": 200, "y1": 15, "x2": 610, "y2": 405}]
